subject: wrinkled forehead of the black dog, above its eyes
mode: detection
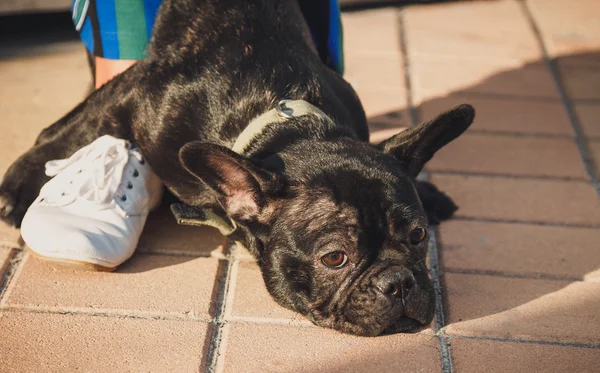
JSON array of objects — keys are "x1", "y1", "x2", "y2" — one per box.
[{"x1": 282, "y1": 166, "x2": 423, "y2": 252}]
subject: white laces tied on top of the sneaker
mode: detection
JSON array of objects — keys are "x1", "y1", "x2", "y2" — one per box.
[{"x1": 42, "y1": 136, "x2": 136, "y2": 203}]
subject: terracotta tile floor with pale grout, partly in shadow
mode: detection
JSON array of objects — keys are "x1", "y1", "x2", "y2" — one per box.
[{"x1": 0, "y1": 0, "x2": 600, "y2": 372}]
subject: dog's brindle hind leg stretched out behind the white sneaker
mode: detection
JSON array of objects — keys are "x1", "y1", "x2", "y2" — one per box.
[{"x1": 0, "y1": 65, "x2": 140, "y2": 227}]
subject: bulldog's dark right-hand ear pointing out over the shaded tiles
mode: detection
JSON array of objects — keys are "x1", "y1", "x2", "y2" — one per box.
[{"x1": 377, "y1": 104, "x2": 475, "y2": 178}]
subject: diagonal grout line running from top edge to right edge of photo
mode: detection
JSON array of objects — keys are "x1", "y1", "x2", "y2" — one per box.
[{"x1": 520, "y1": 1, "x2": 600, "y2": 197}]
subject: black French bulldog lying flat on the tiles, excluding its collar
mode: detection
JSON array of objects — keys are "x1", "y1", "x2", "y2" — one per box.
[{"x1": 0, "y1": 0, "x2": 474, "y2": 336}]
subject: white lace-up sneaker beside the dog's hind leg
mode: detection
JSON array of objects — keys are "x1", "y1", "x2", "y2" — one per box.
[{"x1": 21, "y1": 136, "x2": 163, "y2": 271}]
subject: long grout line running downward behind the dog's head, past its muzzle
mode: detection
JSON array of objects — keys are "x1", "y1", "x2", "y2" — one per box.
[{"x1": 397, "y1": 8, "x2": 454, "y2": 373}]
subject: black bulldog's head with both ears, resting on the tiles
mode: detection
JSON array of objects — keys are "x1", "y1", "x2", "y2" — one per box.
[{"x1": 180, "y1": 105, "x2": 474, "y2": 336}]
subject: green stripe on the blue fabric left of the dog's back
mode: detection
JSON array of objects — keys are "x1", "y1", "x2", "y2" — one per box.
[{"x1": 115, "y1": 0, "x2": 148, "y2": 60}]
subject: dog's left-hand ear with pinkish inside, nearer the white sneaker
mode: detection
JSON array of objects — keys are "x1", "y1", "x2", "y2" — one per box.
[{"x1": 179, "y1": 141, "x2": 279, "y2": 220}]
